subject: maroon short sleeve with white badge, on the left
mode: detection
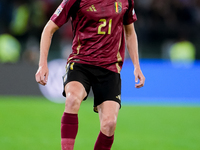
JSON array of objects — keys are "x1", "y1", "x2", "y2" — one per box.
[{"x1": 50, "y1": 0, "x2": 76, "y2": 27}]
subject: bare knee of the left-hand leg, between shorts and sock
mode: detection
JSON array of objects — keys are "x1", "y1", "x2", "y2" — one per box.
[{"x1": 65, "y1": 92, "x2": 82, "y2": 113}]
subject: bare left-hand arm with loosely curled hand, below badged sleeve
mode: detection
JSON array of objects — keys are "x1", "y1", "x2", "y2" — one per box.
[{"x1": 35, "y1": 20, "x2": 59, "y2": 85}]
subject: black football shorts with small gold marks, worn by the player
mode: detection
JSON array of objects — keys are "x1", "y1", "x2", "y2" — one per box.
[{"x1": 63, "y1": 62, "x2": 121, "y2": 112}]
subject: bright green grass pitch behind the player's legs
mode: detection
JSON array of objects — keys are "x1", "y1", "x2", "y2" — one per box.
[{"x1": 0, "y1": 96, "x2": 200, "y2": 150}]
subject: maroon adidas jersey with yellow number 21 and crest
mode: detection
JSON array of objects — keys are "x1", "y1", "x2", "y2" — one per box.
[{"x1": 51, "y1": 0, "x2": 137, "y2": 73}]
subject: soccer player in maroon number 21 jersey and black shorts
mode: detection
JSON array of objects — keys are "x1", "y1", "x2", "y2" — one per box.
[{"x1": 36, "y1": 0, "x2": 145, "y2": 150}]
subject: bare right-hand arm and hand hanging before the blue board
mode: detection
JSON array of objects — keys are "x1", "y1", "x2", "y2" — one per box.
[{"x1": 124, "y1": 24, "x2": 145, "y2": 88}]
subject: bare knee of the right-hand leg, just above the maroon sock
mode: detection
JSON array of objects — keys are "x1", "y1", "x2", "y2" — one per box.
[{"x1": 101, "y1": 117, "x2": 117, "y2": 136}]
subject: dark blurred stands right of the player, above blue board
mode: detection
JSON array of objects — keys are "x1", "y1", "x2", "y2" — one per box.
[{"x1": 135, "y1": 0, "x2": 200, "y2": 59}]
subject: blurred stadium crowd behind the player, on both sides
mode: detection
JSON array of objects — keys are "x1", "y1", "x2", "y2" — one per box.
[{"x1": 0, "y1": 0, "x2": 200, "y2": 63}]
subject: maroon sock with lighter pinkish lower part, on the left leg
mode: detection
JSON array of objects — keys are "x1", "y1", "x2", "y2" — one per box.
[{"x1": 61, "y1": 113, "x2": 78, "y2": 150}]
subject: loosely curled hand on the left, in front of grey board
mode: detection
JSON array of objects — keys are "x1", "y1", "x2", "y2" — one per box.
[{"x1": 35, "y1": 66, "x2": 49, "y2": 85}]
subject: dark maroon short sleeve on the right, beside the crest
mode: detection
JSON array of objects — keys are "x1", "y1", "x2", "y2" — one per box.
[{"x1": 123, "y1": 0, "x2": 137, "y2": 25}]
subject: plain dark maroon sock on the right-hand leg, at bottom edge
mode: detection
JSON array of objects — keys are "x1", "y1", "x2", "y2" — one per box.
[{"x1": 94, "y1": 131, "x2": 114, "y2": 150}]
